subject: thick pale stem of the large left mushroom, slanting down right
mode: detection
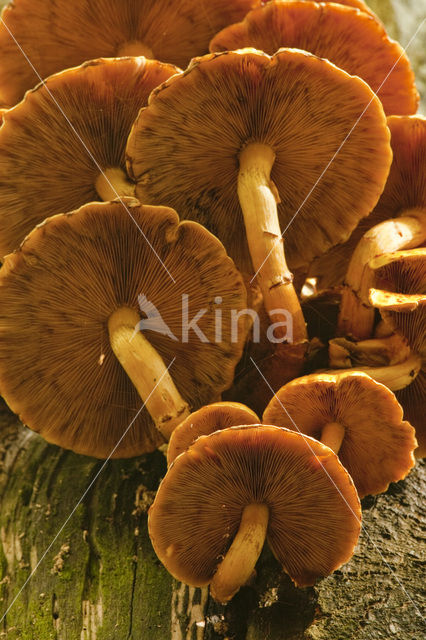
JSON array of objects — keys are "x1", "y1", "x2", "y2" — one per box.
[{"x1": 108, "y1": 307, "x2": 190, "y2": 440}]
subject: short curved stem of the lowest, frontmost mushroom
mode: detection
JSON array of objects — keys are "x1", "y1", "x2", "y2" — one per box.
[{"x1": 210, "y1": 503, "x2": 269, "y2": 602}]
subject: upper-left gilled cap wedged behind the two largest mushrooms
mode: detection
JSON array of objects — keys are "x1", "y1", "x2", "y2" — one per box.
[{"x1": 0, "y1": 57, "x2": 179, "y2": 256}]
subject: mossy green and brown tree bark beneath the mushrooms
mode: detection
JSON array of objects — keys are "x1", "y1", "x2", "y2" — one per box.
[{"x1": 0, "y1": 409, "x2": 426, "y2": 640}]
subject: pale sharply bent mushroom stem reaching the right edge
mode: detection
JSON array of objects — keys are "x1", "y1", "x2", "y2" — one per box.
[{"x1": 337, "y1": 208, "x2": 426, "y2": 340}]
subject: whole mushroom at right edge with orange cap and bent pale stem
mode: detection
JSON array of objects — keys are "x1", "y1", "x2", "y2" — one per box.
[{"x1": 310, "y1": 115, "x2": 426, "y2": 302}]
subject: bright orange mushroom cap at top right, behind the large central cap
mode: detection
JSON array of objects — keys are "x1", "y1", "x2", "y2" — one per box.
[{"x1": 210, "y1": 0, "x2": 419, "y2": 115}]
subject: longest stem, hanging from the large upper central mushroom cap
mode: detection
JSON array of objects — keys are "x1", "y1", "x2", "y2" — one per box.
[{"x1": 238, "y1": 142, "x2": 308, "y2": 344}]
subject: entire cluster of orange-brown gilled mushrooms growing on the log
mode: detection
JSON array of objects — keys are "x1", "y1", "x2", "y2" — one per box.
[{"x1": 0, "y1": 0, "x2": 426, "y2": 602}]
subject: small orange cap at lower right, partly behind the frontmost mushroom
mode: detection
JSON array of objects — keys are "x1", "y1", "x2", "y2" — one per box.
[{"x1": 263, "y1": 371, "x2": 416, "y2": 498}]
